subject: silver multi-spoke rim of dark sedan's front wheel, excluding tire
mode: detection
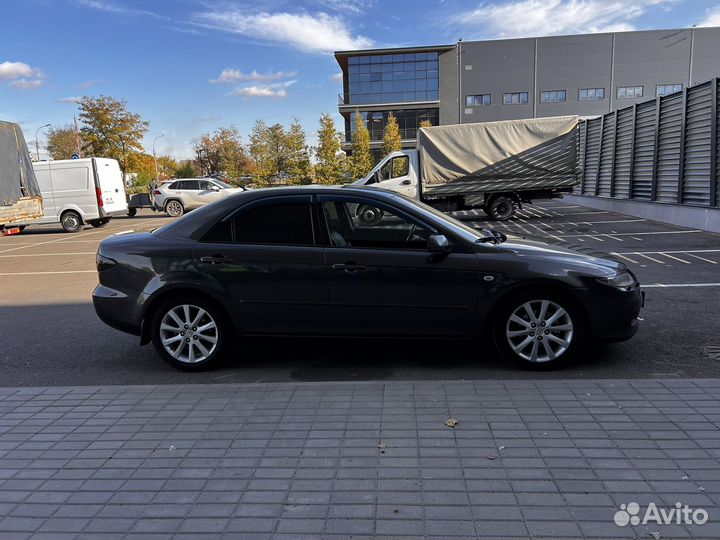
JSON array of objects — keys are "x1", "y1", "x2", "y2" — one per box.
[{"x1": 505, "y1": 300, "x2": 573, "y2": 363}]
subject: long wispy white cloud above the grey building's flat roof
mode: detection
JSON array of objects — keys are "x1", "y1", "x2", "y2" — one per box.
[{"x1": 451, "y1": 0, "x2": 675, "y2": 38}]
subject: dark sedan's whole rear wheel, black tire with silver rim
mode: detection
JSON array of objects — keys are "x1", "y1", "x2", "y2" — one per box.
[{"x1": 151, "y1": 295, "x2": 231, "y2": 371}]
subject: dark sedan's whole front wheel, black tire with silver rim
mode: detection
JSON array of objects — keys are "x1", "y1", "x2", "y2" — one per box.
[{"x1": 493, "y1": 288, "x2": 585, "y2": 370}]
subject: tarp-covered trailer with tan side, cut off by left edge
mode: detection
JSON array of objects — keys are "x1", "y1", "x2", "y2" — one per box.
[{"x1": 0, "y1": 121, "x2": 43, "y2": 232}]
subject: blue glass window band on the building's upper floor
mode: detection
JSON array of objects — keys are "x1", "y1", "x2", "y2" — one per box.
[{"x1": 342, "y1": 52, "x2": 440, "y2": 105}]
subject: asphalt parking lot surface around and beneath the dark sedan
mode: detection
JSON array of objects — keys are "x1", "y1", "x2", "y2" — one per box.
[{"x1": 0, "y1": 201, "x2": 720, "y2": 386}]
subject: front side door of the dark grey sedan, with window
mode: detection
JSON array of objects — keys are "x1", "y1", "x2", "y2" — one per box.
[{"x1": 319, "y1": 195, "x2": 479, "y2": 336}]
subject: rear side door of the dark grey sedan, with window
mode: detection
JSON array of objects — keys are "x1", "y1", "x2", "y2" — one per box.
[{"x1": 193, "y1": 195, "x2": 328, "y2": 334}]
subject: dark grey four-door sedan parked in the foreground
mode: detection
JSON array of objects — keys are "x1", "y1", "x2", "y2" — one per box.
[{"x1": 93, "y1": 186, "x2": 643, "y2": 370}]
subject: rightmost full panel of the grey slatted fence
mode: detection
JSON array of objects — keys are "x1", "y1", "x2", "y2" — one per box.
[{"x1": 682, "y1": 83, "x2": 712, "y2": 206}]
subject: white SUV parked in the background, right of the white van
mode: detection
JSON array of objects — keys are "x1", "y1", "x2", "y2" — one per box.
[{"x1": 153, "y1": 178, "x2": 245, "y2": 217}]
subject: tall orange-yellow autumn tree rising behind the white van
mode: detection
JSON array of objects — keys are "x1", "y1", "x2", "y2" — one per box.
[{"x1": 80, "y1": 96, "x2": 150, "y2": 171}]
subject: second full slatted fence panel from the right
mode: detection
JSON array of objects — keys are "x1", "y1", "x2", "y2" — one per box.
[{"x1": 655, "y1": 94, "x2": 684, "y2": 203}]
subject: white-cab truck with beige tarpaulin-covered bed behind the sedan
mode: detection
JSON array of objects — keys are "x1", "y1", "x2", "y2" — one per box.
[{"x1": 353, "y1": 116, "x2": 581, "y2": 221}]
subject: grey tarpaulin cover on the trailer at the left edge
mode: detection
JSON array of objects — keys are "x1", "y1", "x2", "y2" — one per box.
[{"x1": 0, "y1": 121, "x2": 40, "y2": 206}]
